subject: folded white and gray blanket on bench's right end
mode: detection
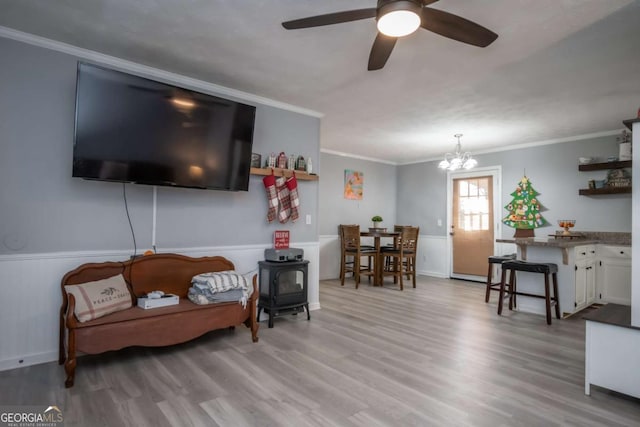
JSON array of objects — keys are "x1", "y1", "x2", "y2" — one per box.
[{"x1": 188, "y1": 270, "x2": 253, "y2": 308}]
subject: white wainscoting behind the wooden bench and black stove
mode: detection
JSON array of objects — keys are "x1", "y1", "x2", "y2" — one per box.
[{"x1": 0, "y1": 242, "x2": 320, "y2": 371}]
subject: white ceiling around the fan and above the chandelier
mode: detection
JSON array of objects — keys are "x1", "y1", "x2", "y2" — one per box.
[{"x1": 0, "y1": 0, "x2": 640, "y2": 164}]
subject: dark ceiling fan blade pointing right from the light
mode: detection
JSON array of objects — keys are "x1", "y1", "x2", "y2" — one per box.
[{"x1": 421, "y1": 7, "x2": 498, "y2": 47}]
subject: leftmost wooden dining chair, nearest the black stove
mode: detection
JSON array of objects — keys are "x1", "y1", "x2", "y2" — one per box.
[{"x1": 339, "y1": 224, "x2": 376, "y2": 289}]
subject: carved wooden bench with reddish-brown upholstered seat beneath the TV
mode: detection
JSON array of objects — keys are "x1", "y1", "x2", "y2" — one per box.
[{"x1": 59, "y1": 254, "x2": 258, "y2": 387}]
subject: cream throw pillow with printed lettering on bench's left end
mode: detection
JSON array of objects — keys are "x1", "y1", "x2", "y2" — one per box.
[{"x1": 64, "y1": 274, "x2": 131, "y2": 322}]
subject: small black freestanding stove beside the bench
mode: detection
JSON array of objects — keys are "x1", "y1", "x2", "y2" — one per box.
[{"x1": 258, "y1": 261, "x2": 311, "y2": 328}]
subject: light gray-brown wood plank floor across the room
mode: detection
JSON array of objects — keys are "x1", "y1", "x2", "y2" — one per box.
[{"x1": 0, "y1": 277, "x2": 640, "y2": 427}]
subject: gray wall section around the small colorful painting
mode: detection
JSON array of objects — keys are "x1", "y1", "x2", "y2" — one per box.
[{"x1": 320, "y1": 153, "x2": 397, "y2": 235}]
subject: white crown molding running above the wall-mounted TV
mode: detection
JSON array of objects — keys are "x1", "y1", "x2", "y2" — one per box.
[{"x1": 0, "y1": 26, "x2": 324, "y2": 118}]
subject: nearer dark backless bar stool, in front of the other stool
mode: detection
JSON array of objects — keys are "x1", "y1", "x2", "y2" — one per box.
[{"x1": 498, "y1": 260, "x2": 560, "y2": 325}]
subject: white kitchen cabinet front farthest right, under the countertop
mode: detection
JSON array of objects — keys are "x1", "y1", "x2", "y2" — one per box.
[{"x1": 596, "y1": 245, "x2": 631, "y2": 305}]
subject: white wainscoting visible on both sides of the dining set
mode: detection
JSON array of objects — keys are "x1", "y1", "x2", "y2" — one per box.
[{"x1": 320, "y1": 234, "x2": 449, "y2": 280}]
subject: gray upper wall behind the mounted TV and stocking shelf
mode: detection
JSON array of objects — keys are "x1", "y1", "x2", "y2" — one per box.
[{"x1": 0, "y1": 38, "x2": 320, "y2": 254}]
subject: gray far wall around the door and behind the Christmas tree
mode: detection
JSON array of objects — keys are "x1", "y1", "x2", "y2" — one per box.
[{"x1": 398, "y1": 136, "x2": 631, "y2": 237}]
